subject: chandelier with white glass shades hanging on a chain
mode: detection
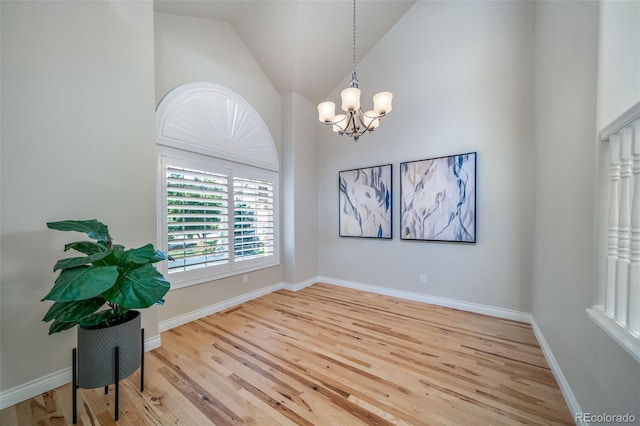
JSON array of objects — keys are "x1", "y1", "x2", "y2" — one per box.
[{"x1": 318, "y1": 0, "x2": 393, "y2": 141}]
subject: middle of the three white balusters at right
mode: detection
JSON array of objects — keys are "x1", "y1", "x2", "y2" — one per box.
[{"x1": 615, "y1": 127, "x2": 633, "y2": 326}]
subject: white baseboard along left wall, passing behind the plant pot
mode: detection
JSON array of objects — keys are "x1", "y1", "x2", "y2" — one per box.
[{"x1": 0, "y1": 335, "x2": 160, "y2": 410}]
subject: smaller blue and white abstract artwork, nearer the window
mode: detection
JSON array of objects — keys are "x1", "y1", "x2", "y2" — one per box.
[{"x1": 338, "y1": 164, "x2": 391, "y2": 238}]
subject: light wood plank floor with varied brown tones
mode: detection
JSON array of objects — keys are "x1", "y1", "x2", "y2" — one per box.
[{"x1": 0, "y1": 284, "x2": 574, "y2": 426}]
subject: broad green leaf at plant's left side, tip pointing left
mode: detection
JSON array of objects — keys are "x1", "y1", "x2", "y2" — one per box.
[{"x1": 42, "y1": 266, "x2": 118, "y2": 302}]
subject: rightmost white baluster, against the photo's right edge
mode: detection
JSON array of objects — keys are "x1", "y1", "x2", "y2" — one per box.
[{"x1": 627, "y1": 119, "x2": 640, "y2": 334}]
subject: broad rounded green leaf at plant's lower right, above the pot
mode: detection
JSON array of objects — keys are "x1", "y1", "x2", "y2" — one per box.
[{"x1": 102, "y1": 264, "x2": 170, "y2": 309}]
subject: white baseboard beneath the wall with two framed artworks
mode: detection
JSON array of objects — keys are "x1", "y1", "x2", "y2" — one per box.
[{"x1": 318, "y1": 277, "x2": 531, "y2": 323}]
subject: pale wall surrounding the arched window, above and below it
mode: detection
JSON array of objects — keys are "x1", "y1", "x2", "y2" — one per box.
[{"x1": 155, "y1": 14, "x2": 287, "y2": 321}]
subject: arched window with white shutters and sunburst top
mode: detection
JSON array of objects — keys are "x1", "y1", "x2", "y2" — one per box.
[{"x1": 156, "y1": 83, "x2": 280, "y2": 288}]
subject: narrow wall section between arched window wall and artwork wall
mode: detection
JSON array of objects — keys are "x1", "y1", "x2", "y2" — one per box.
[{"x1": 281, "y1": 93, "x2": 318, "y2": 285}]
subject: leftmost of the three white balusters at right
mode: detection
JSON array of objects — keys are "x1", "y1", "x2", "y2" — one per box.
[{"x1": 604, "y1": 134, "x2": 620, "y2": 317}]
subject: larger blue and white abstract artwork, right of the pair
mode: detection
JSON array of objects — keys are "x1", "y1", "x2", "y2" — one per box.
[{"x1": 400, "y1": 152, "x2": 476, "y2": 243}]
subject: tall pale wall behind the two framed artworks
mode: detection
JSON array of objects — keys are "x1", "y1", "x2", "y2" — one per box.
[{"x1": 317, "y1": 1, "x2": 534, "y2": 312}]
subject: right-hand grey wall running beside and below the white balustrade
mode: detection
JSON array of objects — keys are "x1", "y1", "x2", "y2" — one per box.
[{"x1": 532, "y1": 1, "x2": 640, "y2": 418}]
